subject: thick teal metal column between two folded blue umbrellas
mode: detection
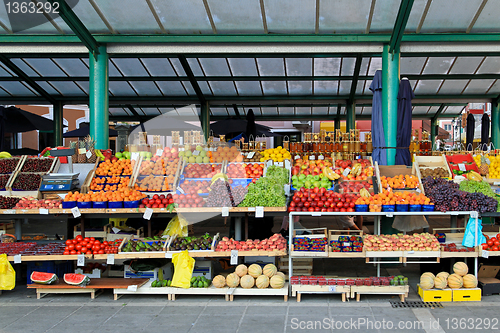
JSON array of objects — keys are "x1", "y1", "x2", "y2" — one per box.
[{"x1": 382, "y1": 44, "x2": 400, "y2": 165}]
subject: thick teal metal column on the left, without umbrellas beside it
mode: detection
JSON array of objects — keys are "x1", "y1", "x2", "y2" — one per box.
[{"x1": 89, "y1": 46, "x2": 109, "y2": 149}]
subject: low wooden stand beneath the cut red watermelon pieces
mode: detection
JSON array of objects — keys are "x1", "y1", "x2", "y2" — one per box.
[{"x1": 28, "y1": 278, "x2": 149, "y2": 300}]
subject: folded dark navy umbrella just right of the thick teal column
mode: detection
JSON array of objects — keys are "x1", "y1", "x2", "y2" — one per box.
[{"x1": 396, "y1": 79, "x2": 415, "y2": 165}]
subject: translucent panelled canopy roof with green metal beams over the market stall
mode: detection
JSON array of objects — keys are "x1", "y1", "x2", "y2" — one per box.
[{"x1": 0, "y1": 0, "x2": 500, "y2": 120}]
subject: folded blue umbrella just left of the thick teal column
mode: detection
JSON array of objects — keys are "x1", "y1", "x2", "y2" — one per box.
[{"x1": 370, "y1": 70, "x2": 387, "y2": 165}]
